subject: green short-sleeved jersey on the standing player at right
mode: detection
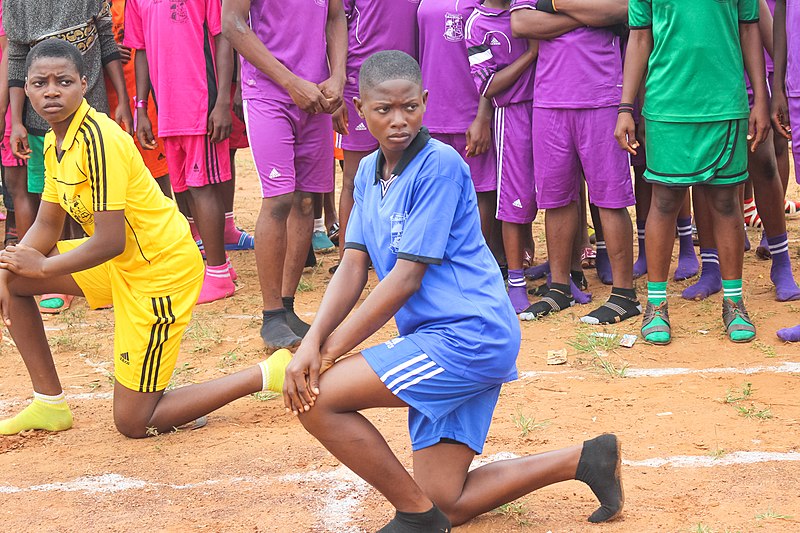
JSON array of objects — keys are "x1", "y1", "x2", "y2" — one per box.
[{"x1": 628, "y1": 0, "x2": 758, "y2": 122}]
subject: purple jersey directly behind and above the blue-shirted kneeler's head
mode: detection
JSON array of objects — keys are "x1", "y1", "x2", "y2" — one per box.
[{"x1": 344, "y1": 0, "x2": 419, "y2": 96}]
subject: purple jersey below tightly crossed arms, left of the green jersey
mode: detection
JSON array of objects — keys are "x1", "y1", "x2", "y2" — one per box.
[{"x1": 511, "y1": 1, "x2": 622, "y2": 109}]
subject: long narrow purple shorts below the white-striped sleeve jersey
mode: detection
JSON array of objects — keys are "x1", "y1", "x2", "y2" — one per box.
[{"x1": 494, "y1": 102, "x2": 536, "y2": 224}]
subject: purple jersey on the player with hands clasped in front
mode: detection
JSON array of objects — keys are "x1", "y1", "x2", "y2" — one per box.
[{"x1": 241, "y1": 0, "x2": 330, "y2": 103}]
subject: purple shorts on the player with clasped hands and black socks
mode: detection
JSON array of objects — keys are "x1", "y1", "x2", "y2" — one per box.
[{"x1": 244, "y1": 99, "x2": 333, "y2": 198}]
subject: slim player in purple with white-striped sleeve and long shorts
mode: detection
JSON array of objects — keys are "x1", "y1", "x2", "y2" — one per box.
[{"x1": 464, "y1": 0, "x2": 538, "y2": 313}]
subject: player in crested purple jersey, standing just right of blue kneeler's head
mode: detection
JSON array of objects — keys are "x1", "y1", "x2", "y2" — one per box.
[{"x1": 417, "y1": 0, "x2": 502, "y2": 257}]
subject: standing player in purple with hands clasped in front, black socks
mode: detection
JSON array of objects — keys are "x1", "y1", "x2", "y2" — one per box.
[{"x1": 222, "y1": 0, "x2": 347, "y2": 350}]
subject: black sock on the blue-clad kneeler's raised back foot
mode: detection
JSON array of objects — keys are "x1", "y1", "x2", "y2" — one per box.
[{"x1": 575, "y1": 433, "x2": 625, "y2": 523}]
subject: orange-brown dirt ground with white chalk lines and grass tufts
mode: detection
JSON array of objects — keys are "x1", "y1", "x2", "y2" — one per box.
[{"x1": 0, "y1": 151, "x2": 800, "y2": 533}]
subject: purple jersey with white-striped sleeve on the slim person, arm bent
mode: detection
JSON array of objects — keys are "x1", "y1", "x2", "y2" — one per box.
[{"x1": 464, "y1": 6, "x2": 533, "y2": 107}]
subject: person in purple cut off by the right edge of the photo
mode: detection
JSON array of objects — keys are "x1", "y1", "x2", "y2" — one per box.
[{"x1": 771, "y1": 0, "x2": 800, "y2": 342}]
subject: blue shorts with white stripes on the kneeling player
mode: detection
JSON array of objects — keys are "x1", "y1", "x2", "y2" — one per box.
[{"x1": 361, "y1": 335, "x2": 501, "y2": 453}]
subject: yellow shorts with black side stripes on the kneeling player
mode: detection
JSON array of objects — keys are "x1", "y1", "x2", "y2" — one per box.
[{"x1": 58, "y1": 239, "x2": 203, "y2": 392}]
